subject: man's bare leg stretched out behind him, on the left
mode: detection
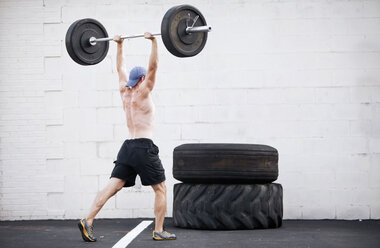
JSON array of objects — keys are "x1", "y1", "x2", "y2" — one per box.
[{"x1": 86, "y1": 177, "x2": 125, "y2": 226}]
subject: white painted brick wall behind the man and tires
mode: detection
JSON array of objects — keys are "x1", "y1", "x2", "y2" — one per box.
[{"x1": 0, "y1": 0, "x2": 380, "y2": 220}]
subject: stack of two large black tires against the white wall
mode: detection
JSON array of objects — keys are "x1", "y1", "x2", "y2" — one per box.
[{"x1": 173, "y1": 144, "x2": 283, "y2": 230}]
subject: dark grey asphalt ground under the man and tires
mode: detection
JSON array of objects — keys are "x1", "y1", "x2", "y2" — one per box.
[{"x1": 0, "y1": 219, "x2": 380, "y2": 248}]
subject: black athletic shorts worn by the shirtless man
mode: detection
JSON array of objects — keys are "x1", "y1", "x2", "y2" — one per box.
[{"x1": 111, "y1": 138, "x2": 165, "y2": 187}]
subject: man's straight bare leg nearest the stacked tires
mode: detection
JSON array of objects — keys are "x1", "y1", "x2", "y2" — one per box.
[{"x1": 152, "y1": 181, "x2": 166, "y2": 232}]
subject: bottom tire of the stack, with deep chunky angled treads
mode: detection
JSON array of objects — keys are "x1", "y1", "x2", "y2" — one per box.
[{"x1": 173, "y1": 183, "x2": 283, "y2": 230}]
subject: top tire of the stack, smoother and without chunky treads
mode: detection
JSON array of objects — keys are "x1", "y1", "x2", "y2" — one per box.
[{"x1": 173, "y1": 144, "x2": 278, "y2": 184}]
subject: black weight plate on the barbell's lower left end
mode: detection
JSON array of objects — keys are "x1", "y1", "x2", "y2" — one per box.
[{"x1": 66, "y1": 18, "x2": 109, "y2": 65}]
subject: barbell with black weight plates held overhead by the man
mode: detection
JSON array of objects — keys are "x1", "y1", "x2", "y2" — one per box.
[{"x1": 65, "y1": 5, "x2": 211, "y2": 65}]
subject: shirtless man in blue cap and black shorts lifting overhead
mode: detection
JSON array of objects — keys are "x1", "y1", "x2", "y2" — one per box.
[{"x1": 78, "y1": 33, "x2": 176, "y2": 242}]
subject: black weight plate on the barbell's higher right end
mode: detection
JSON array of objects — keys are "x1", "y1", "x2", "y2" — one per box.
[{"x1": 161, "y1": 5, "x2": 207, "y2": 57}]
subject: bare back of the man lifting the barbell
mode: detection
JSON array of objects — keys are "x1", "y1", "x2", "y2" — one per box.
[{"x1": 122, "y1": 87, "x2": 154, "y2": 139}]
